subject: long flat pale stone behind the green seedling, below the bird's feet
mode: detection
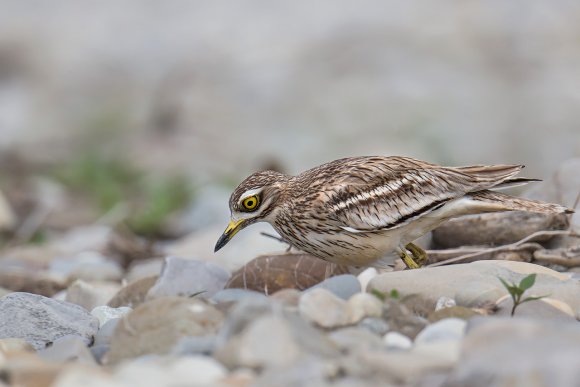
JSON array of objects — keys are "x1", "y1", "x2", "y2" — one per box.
[{"x1": 368, "y1": 261, "x2": 580, "y2": 317}]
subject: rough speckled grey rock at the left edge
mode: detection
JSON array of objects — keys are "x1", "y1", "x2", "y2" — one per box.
[{"x1": 0, "y1": 293, "x2": 99, "y2": 349}]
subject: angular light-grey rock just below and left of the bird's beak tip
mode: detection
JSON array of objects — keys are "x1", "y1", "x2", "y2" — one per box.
[{"x1": 147, "y1": 256, "x2": 230, "y2": 298}]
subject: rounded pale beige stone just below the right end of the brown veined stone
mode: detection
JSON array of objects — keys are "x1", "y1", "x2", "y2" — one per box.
[{"x1": 298, "y1": 288, "x2": 351, "y2": 328}]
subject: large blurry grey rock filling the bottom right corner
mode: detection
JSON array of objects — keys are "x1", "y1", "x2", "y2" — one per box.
[{"x1": 445, "y1": 318, "x2": 580, "y2": 387}]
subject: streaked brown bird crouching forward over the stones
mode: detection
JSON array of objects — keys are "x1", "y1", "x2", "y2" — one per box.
[{"x1": 214, "y1": 156, "x2": 574, "y2": 269}]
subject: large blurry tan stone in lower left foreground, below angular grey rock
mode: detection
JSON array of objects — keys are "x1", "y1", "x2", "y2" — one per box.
[{"x1": 103, "y1": 297, "x2": 223, "y2": 364}]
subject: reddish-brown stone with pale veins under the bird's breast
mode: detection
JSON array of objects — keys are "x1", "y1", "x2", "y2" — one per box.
[{"x1": 226, "y1": 254, "x2": 348, "y2": 294}]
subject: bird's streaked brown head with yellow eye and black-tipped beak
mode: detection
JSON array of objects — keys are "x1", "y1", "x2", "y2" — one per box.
[{"x1": 214, "y1": 171, "x2": 288, "y2": 251}]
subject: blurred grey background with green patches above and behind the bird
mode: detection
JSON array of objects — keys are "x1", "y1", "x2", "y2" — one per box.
[{"x1": 0, "y1": 0, "x2": 580, "y2": 247}]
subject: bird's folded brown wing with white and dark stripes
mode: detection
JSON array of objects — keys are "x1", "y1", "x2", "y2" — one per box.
[{"x1": 325, "y1": 158, "x2": 521, "y2": 233}]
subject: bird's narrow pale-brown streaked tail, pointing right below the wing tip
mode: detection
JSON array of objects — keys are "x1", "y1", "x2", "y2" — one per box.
[{"x1": 469, "y1": 190, "x2": 574, "y2": 214}]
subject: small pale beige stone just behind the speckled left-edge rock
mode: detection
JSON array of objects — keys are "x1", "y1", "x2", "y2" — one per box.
[{"x1": 65, "y1": 280, "x2": 121, "y2": 310}]
